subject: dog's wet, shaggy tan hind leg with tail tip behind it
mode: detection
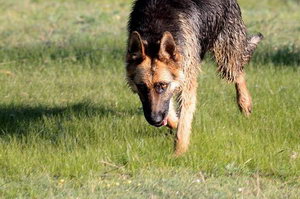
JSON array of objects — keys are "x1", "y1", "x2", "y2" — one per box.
[{"x1": 213, "y1": 23, "x2": 263, "y2": 116}]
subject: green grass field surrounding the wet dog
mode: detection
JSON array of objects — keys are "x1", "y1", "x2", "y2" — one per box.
[{"x1": 0, "y1": 0, "x2": 300, "y2": 198}]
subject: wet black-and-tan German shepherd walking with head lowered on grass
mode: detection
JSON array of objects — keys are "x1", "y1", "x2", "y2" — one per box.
[{"x1": 126, "y1": 0, "x2": 263, "y2": 155}]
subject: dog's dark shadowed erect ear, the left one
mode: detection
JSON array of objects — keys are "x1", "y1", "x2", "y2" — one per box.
[{"x1": 127, "y1": 31, "x2": 145, "y2": 61}]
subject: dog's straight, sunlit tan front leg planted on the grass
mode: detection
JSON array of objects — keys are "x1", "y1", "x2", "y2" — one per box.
[{"x1": 175, "y1": 78, "x2": 197, "y2": 156}]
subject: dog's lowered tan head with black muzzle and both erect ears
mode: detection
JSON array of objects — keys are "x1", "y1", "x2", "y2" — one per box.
[{"x1": 126, "y1": 32, "x2": 183, "y2": 127}]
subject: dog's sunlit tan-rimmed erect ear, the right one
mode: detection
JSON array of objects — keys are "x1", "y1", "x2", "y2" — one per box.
[{"x1": 158, "y1": 31, "x2": 179, "y2": 61}]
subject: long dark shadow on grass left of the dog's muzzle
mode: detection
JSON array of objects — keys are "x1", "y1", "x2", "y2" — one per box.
[{"x1": 0, "y1": 102, "x2": 142, "y2": 138}]
